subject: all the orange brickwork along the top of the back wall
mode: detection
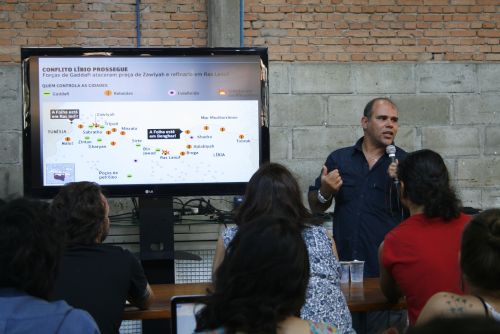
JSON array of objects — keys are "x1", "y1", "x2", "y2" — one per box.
[{"x1": 0, "y1": 0, "x2": 500, "y2": 62}]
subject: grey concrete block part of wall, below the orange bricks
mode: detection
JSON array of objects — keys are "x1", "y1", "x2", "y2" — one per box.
[{"x1": 0, "y1": 62, "x2": 500, "y2": 208}]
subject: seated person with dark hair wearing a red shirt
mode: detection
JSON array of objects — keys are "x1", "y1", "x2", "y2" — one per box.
[{"x1": 379, "y1": 149, "x2": 470, "y2": 325}]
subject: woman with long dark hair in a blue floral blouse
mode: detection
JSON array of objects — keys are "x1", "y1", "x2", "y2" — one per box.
[{"x1": 214, "y1": 163, "x2": 352, "y2": 332}]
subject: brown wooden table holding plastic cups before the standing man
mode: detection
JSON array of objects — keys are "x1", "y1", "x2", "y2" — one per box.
[{"x1": 123, "y1": 278, "x2": 406, "y2": 320}]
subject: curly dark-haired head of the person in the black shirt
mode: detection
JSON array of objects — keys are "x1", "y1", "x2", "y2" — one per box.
[{"x1": 51, "y1": 181, "x2": 109, "y2": 245}]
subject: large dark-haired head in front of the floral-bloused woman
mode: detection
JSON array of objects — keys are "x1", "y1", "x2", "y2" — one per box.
[{"x1": 197, "y1": 216, "x2": 309, "y2": 333}]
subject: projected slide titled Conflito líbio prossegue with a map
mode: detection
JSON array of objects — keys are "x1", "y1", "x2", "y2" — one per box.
[{"x1": 38, "y1": 56, "x2": 261, "y2": 186}]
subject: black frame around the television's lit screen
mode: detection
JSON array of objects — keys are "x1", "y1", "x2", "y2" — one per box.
[{"x1": 21, "y1": 47, "x2": 270, "y2": 198}]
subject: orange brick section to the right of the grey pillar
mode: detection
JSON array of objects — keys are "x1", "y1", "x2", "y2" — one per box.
[{"x1": 245, "y1": 0, "x2": 500, "y2": 62}]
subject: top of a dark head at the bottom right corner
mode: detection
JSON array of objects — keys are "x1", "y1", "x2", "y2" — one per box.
[{"x1": 406, "y1": 316, "x2": 500, "y2": 334}]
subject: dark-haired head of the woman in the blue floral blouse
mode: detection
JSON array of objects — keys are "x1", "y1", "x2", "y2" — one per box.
[{"x1": 235, "y1": 163, "x2": 311, "y2": 225}]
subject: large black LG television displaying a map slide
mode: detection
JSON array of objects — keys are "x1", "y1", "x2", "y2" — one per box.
[{"x1": 21, "y1": 48, "x2": 269, "y2": 198}]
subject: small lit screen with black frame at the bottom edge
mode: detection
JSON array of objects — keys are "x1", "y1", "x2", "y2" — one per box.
[{"x1": 170, "y1": 295, "x2": 204, "y2": 334}]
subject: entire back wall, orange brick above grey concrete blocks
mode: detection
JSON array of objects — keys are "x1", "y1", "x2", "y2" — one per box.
[{"x1": 0, "y1": 0, "x2": 500, "y2": 208}]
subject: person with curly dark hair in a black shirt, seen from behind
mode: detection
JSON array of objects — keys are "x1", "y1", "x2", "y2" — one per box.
[{"x1": 50, "y1": 181, "x2": 153, "y2": 334}]
